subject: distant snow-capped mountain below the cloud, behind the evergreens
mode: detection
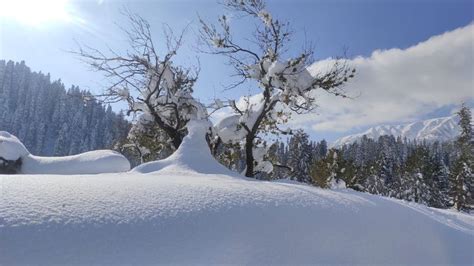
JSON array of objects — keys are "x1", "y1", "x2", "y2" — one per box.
[{"x1": 332, "y1": 115, "x2": 459, "y2": 147}]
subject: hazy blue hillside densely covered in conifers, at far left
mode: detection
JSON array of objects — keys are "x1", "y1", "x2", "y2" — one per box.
[{"x1": 0, "y1": 60, "x2": 129, "y2": 155}]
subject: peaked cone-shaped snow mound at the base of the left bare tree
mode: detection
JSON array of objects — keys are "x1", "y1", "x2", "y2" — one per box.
[{"x1": 131, "y1": 120, "x2": 237, "y2": 176}]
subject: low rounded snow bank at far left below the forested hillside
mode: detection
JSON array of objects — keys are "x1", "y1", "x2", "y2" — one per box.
[{"x1": 0, "y1": 131, "x2": 130, "y2": 175}]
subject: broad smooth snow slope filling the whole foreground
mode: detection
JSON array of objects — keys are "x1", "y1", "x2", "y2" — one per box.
[{"x1": 0, "y1": 171, "x2": 474, "y2": 265}]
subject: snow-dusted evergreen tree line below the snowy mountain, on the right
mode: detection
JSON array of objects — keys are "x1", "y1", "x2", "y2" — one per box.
[{"x1": 212, "y1": 106, "x2": 474, "y2": 210}]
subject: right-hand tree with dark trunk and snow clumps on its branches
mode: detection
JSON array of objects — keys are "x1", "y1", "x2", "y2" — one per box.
[{"x1": 200, "y1": 0, "x2": 355, "y2": 177}]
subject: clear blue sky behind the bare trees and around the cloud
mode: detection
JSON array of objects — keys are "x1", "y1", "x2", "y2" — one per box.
[{"x1": 0, "y1": 0, "x2": 474, "y2": 139}]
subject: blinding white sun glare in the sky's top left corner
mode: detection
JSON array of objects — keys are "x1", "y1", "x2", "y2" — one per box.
[{"x1": 0, "y1": 0, "x2": 72, "y2": 26}]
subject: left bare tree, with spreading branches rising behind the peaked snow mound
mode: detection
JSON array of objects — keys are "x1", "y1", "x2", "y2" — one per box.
[{"x1": 73, "y1": 12, "x2": 206, "y2": 149}]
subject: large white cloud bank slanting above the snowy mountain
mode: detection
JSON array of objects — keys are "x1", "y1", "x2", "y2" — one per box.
[{"x1": 292, "y1": 24, "x2": 474, "y2": 132}]
